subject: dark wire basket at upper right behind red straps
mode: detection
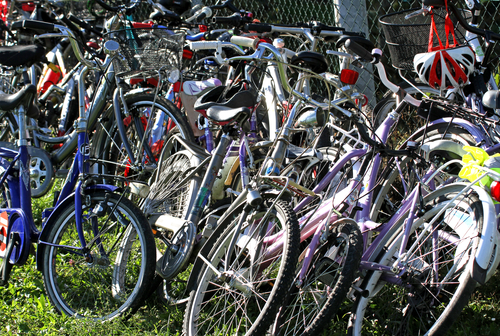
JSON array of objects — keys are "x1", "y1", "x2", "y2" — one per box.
[{"x1": 379, "y1": 8, "x2": 471, "y2": 71}]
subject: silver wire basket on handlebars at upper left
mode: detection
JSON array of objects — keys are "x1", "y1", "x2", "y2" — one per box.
[{"x1": 108, "y1": 28, "x2": 185, "y2": 77}]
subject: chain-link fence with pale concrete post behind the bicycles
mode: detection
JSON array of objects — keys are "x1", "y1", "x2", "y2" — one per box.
[{"x1": 132, "y1": 0, "x2": 500, "y2": 102}]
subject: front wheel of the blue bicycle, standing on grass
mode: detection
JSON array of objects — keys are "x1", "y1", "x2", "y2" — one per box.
[{"x1": 41, "y1": 191, "x2": 156, "y2": 320}]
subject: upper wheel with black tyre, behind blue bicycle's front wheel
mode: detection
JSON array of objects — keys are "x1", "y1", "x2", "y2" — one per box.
[{"x1": 90, "y1": 93, "x2": 194, "y2": 180}]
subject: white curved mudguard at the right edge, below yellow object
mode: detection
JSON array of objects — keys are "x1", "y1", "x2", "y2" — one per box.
[{"x1": 471, "y1": 186, "x2": 500, "y2": 284}]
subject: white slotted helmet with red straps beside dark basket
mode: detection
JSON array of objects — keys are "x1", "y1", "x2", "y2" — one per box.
[{"x1": 413, "y1": 46, "x2": 475, "y2": 90}]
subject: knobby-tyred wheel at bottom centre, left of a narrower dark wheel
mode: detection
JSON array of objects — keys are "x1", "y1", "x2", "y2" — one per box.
[{"x1": 184, "y1": 199, "x2": 299, "y2": 335}]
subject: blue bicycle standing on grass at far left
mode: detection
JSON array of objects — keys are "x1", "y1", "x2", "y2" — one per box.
[{"x1": 0, "y1": 39, "x2": 155, "y2": 320}]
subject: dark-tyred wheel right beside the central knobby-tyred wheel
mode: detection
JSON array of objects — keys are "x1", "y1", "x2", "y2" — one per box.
[{"x1": 273, "y1": 219, "x2": 363, "y2": 335}]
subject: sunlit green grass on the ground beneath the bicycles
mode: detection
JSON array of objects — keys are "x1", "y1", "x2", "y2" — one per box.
[{"x1": 0, "y1": 184, "x2": 500, "y2": 336}]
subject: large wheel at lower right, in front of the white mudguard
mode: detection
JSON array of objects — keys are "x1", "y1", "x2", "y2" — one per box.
[{"x1": 350, "y1": 185, "x2": 483, "y2": 335}]
